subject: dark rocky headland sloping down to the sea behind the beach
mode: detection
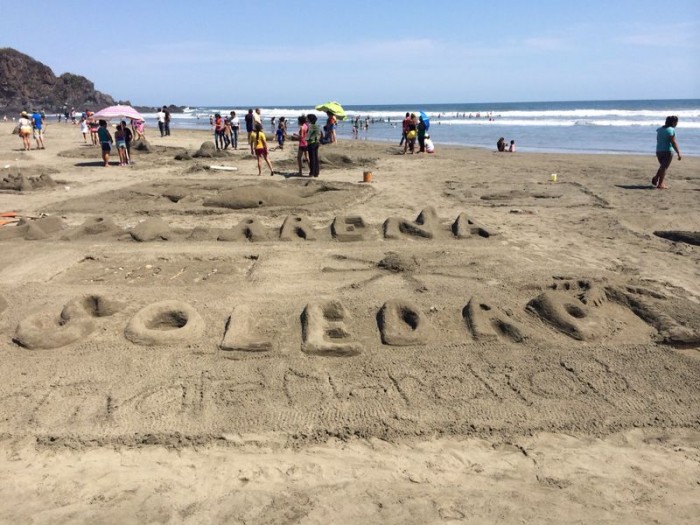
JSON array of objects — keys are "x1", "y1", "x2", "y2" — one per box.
[{"x1": 0, "y1": 47, "x2": 129, "y2": 114}]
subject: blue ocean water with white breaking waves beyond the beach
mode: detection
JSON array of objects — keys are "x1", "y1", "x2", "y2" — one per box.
[{"x1": 145, "y1": 99, "x2": 700, "y2": 156}]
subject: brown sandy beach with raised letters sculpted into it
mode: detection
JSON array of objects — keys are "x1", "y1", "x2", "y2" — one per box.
[{"x1": 0, "y1": 123, "x2": 700, "y2": 523}]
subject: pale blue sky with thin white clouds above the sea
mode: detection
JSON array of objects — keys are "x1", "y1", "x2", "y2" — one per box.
[{"x1": 0, "y1": 0, "x2": 700, "y2": 106}]
